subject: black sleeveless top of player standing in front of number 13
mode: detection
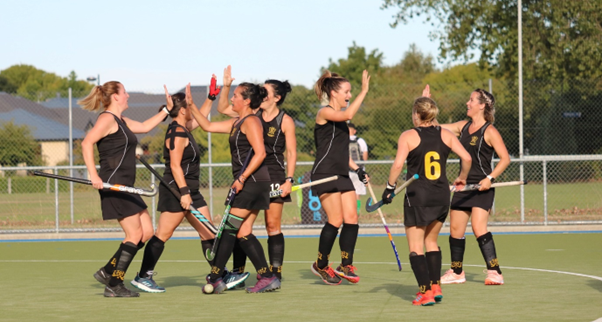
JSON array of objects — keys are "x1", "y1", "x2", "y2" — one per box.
[{"x1": 229, "y1": 114, "x2": 270, "y2": 182}]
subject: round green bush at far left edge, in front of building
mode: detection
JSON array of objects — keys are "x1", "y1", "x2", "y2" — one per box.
[{"x1": 0, "y1": 121, "x2": 42, "y2": 166}]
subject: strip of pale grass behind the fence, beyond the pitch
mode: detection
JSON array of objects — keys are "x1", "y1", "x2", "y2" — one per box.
[{"x1": 0, "y1": 183, "x2": 602, "y2": 230}]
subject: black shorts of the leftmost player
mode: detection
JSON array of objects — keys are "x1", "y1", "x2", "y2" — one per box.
[{"x1": 98, "y1": 190, "x2": 148, "y2": 220}]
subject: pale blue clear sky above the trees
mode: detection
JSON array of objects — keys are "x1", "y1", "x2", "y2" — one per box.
[{"x1": 0, "y1": 0, "x2": 438, "y2": 93}]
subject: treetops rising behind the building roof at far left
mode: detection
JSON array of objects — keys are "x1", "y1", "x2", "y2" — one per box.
[{"x1": 0, "y1": 65, "x2": 93, "y2": 102}]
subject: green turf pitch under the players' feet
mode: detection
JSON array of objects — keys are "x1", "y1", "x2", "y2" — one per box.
[{"x1": 0, "y1": 234, "x2": 602, "y2": 322}]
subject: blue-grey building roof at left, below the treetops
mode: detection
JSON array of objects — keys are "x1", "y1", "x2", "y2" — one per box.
[{"x1": 0, "y1": 109, "x2": 86, "y2": 141}]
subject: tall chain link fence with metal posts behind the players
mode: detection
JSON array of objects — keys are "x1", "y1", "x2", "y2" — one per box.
[{"x1": 0, "y1": 80, "x2": 602, "y2": 233}]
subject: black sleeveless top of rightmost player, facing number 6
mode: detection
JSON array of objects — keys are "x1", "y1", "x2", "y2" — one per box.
[{"x1": 460, "y1": 121, "x2": 495, "y2": 184}]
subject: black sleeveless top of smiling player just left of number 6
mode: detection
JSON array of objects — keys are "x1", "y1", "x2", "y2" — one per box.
[{"x1": 312, "y1": 107, "x2": 349, "y2": 176}]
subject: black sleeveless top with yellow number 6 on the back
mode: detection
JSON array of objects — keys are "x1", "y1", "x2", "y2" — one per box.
[{"x1": 405, "y1": 126, "x2": 451, "y2": 207}]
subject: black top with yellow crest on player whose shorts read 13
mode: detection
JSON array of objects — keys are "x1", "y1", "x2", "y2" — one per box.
[{"x1": 257, "y1": 109, "x2": 286, "y2": 170}]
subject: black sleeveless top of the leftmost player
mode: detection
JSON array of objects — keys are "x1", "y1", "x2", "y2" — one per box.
[{"x1": 96, "y1": 111, "x2": 138, "y2": 186}]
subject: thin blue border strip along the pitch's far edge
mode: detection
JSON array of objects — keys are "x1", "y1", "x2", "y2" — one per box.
[{"x1": 0, "y1": 231, "x2": 602, "y2": 243}]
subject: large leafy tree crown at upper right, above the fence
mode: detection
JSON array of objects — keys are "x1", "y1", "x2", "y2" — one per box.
[{"x1": 381, "y1": 0, "x2": 602, "y2": 80}]
